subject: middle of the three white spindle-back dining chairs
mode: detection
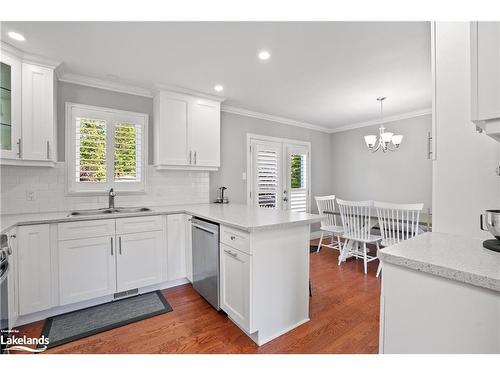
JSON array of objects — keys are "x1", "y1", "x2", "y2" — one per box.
[{"x1": 337, "y1": 199, "x2": 382, "y2": 274}]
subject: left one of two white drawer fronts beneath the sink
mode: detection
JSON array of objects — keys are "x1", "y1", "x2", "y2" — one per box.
[{"x1": 58, "y1": 219, "x2": 115, "y2": 240}]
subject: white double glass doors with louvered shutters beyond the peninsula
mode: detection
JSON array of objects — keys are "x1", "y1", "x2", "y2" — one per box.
[{"x1": 247, "y1": 137, "x2": 310, "y2": 212}]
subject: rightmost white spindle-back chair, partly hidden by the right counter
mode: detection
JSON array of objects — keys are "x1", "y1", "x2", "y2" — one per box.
[{"x1": 373, "y1": 202, "x2": 424, "y2": 277}]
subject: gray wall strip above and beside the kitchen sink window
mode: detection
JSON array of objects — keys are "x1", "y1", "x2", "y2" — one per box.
[{"x1": 57, "y1": 81, "x2": 153, "y2": 164}]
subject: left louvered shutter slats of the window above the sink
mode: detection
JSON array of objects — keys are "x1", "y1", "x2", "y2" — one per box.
[{"x1": 75, "y1": 117, "x2": 107, "y2": 182}]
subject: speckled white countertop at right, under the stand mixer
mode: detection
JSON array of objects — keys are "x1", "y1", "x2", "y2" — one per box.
[{"x1": 379, "y1": 232, "x2": 500, "y2": 291}]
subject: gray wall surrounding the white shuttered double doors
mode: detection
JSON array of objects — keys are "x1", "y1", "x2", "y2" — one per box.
[{"x1": 210, "y1": 112, "x2": 332, "y2": 217}]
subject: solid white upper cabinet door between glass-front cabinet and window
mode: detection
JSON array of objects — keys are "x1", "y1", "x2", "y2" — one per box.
[{"x1": 21, "y1": 63, "x2": 56, "y2": 160}]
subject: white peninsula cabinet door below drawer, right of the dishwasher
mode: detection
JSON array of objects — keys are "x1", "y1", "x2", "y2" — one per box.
[{"x1": 220, "y1": 243, "x2": 251, "y2": 332}]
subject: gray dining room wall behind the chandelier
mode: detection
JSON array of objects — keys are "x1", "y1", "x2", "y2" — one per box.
[{"x1": 330, "y1": 115, "x2": 432, "y2": 210}]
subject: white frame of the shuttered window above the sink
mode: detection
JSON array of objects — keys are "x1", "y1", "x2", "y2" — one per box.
[{"x1": 65, "y1": 102, "x2": 149, "y2": 195}]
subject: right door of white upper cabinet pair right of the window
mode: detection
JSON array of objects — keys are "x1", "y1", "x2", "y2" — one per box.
[{"x1": 190, "y1": 100, "x2": 220, "y2": 167}]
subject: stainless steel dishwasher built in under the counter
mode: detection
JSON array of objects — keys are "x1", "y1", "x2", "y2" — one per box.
[{"x1": 191, "y1": 217, "x2": 220, "y2": 310}]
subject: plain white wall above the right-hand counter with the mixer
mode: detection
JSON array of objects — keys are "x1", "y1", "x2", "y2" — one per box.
[{"x1": 433, "y1": 22, "x2": 500, "y2": 238}]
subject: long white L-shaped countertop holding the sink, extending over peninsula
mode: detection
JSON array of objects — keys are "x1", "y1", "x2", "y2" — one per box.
[{"x1": 0, "y1": 203, "x2": 321, "y2": 232}]
